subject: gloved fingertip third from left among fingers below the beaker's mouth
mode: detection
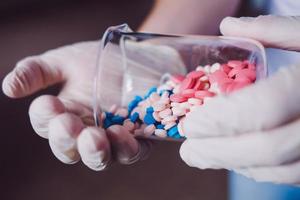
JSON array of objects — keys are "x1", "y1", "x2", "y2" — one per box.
[{"x1": 77, "y1": 127, "x2": 111, "y2": 171}]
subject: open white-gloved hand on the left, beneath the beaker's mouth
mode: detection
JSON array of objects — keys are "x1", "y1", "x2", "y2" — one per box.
[{"x1": 2, "y1": 42, "x2": 184, "y2": 170}]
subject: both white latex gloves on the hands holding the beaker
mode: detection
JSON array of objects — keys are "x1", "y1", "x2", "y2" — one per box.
[{"x1": 3, "y1": 16, "x2": 300, "y2": 185}]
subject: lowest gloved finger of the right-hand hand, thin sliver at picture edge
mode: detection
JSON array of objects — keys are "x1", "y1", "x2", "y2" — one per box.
[{"x1": 234, "y1": 161, "x2": 300, "y2": 185}]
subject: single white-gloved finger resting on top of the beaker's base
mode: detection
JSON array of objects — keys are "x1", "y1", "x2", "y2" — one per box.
[{"x1": 220, "y1": 15, "x2": 300, "y2": 51}]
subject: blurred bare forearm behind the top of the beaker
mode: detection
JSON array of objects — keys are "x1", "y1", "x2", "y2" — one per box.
[{"x1": 139, "y1": 0, "x2": 240, "y2": 35}]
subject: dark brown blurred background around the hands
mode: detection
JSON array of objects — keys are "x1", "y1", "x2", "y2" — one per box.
[{"x1": 0, "y1": 0, "x2": 227, "y2": 200}]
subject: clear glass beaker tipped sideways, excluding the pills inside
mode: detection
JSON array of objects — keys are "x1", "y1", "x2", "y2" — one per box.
[{"x1": 93, "y1": 24, "x2": 267, "y2": 139}]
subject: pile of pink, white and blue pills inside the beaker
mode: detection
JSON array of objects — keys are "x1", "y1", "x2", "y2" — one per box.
[{"x1": 102, "y1": 60, "x2": 256, "y2": 139}]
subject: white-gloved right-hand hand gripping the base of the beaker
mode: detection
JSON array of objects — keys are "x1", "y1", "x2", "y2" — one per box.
[{"x1": 179, "y1": 16, "x2": 300, "y2": 185}]
